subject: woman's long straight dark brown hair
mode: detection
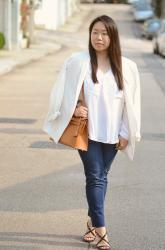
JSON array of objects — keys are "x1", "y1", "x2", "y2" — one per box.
[{"x1": 89, "y1": 15, "x2": 123, "y2": 90}]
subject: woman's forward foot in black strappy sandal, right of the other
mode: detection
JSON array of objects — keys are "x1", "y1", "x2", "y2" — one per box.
[{"x1": 95, "y1": 227, "x2": 111, "y2": 250}]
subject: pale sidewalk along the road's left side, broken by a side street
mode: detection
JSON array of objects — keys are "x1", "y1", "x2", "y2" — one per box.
[{"x1": 0, "y1": 5, "x2": 91, "y2": 76}]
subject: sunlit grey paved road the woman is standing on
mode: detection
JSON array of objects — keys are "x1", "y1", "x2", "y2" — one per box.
[{"x1": 0, "y1": 5, "x2": 165, "y2": 250}]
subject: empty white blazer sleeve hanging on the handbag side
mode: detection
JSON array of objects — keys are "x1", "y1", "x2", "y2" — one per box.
[{"x1": 45, "y1": 59, "x2": 68, "y2": 122}]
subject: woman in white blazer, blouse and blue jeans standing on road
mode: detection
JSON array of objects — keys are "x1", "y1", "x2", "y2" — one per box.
[{"x1": 43, "y1": 15, "x2": 140, "y2": 249}]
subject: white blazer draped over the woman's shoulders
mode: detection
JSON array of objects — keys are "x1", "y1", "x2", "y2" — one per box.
[{"x1": 43, "y1": 51, "x2": 141, "y2": 160}]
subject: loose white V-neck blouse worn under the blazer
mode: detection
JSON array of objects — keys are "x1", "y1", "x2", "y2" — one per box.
[{"x1": 84, "y1": 63, "x2": 129, "y2": 144}]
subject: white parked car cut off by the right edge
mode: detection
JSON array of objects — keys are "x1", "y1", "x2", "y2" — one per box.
[{"x1": 153, "y1": 20, "x2": 165, "y2": 56}]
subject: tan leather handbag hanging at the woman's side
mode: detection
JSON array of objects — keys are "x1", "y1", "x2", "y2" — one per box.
[{"x1": 59, "y1": 83, "x2": 88, "y2": 151}]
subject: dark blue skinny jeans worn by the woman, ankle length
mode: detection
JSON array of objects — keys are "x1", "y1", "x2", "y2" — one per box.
[{"x1": 78, "y1": 139, "x2": 117, "y2": 227}]
